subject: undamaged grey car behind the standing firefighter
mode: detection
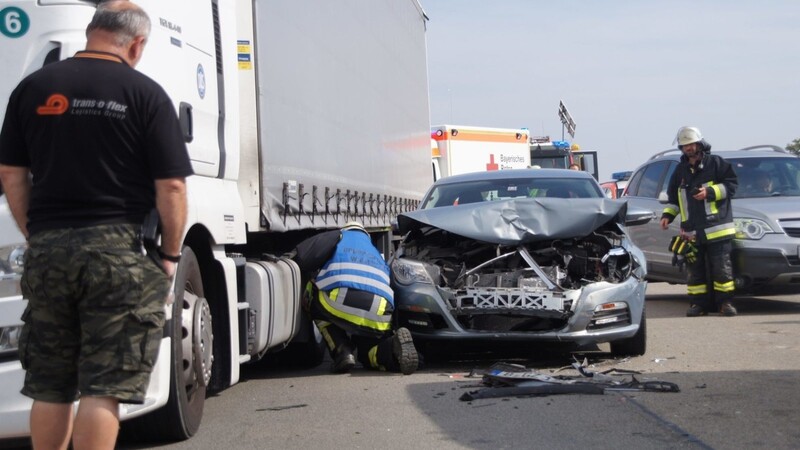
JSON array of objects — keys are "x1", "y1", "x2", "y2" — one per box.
[{"x1": 625, "y1": 145, "x2": 800, "y2": 293}]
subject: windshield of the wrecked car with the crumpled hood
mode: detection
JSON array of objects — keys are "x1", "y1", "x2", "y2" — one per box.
[{"x1": 421, "y1": 178, "x2": 603, "y2": 209}]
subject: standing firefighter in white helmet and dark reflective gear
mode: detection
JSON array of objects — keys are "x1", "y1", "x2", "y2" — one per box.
[{"x1": 661, "y1": 127, "x2": 738, "y2": 317}]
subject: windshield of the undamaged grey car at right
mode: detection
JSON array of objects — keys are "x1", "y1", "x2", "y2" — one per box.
[{"x1": 728, "y1": 158, "x2": 800, "y2": 198}]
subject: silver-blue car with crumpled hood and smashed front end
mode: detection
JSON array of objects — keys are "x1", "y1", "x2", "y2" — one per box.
[{"x1": 390, "y1": 169, "x2": 652, "y2": 355}]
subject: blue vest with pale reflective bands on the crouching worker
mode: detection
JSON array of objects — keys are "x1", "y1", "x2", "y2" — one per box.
[{"x1": 315, "y1": 230, "x2": 394, "y2": 305}]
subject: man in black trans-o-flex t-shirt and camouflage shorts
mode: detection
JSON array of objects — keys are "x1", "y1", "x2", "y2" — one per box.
[{"x1": 0, "y1": 1, "x2": 193, "y2": 448}]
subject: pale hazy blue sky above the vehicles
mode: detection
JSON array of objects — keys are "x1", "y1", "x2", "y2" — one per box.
[{"x1": 419, "y1": 0, "x2": 800, "y2": 181}]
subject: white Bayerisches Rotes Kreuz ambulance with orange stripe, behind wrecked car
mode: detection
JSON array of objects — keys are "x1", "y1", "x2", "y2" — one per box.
[{"x1": 431, "y1": 125, "x2": 531, "y2": 180}]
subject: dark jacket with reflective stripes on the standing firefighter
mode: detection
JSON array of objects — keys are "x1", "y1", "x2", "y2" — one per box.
[{"x1": 661, "y1": 153, "x2": 739, "y2": 243}]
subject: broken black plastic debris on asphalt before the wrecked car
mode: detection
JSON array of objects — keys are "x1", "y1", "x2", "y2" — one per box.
[{"x1": 460, "y1": 362, "x2": 680, "y2": 401}]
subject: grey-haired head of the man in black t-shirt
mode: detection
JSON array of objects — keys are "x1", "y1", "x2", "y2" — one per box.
[{"x1": 86, "y1": 0, "x2": 150, "y2": 66}]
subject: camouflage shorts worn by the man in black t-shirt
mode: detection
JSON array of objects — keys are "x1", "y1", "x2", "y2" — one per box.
[{"x1": 19, "y1": 225, "x2": 170, "y2": 403}]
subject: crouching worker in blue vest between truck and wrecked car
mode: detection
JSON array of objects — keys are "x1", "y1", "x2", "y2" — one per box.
[{"x1": 293, "y1": 222, "x2": 419, "y2": 375}]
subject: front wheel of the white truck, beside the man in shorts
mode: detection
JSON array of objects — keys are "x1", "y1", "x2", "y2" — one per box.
[{"x1": 123, "y1": 247, "x2": 209, "y2": 441}]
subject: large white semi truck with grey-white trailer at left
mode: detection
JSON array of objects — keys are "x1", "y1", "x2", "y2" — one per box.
[{"x1": 0, "y1": 0, "x2": 432, "y2": 439}]
